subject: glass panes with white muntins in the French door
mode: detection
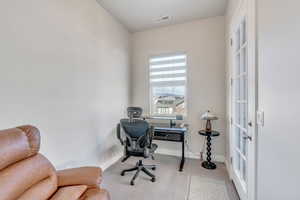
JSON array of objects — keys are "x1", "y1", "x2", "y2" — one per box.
[{"x1": 232, "y1": 14, "x2": 250, "y2": 196}]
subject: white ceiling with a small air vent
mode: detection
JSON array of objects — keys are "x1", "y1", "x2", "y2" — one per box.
[{"x1": 97, "y1": 0, "x2": 227, "y2": 32}]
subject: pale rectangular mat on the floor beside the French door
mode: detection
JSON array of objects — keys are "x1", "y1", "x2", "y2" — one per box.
[{"x1": 188, "y1": 176, "x2": 229, "y2": 200}]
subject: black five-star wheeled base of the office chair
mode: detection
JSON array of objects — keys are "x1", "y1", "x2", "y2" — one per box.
[{"x1": 121, "y1": 160, "x2": 156, "y2": 185}]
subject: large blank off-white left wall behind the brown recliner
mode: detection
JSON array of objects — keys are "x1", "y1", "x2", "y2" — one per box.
[{"x1": 0, "y1": 0, "x2": 130, "y2": 167}]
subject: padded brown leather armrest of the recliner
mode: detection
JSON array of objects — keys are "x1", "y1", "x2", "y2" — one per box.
[{"x1": 57, "y1": 167, "x2": 102, "y2": 188}]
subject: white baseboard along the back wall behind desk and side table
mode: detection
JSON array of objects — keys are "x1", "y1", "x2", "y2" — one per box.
[{"x1": 155, "y1": 148, "x2": 225, "y2": 163}]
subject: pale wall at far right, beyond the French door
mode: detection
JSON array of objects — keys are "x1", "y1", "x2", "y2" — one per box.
[{"x1": 257, "y1": 0, "x2": 300, "y2": 200}]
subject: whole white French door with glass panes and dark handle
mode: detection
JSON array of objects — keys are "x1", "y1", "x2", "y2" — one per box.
[{"x1": 230, "y1": 1, "x2": 256, "y2": 200}]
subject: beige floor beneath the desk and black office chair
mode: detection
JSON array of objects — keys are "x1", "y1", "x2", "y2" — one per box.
[{"x1": 102, "y1": 154, "x2": 238, "y2": 200}]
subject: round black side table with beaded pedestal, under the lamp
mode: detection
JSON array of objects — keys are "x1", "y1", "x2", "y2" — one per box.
[{"x1": 199, "y1": 130, "x2": 220, "y2": 169}]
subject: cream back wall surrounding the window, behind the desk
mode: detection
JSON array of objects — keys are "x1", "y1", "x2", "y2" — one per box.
[{"x1": 131, "y1": 17, "x2": 226, "y2": 159}]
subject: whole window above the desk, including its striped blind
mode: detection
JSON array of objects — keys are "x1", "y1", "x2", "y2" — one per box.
[{"x1": 149, "y1": 54, "x2": 186, "y2": 116}]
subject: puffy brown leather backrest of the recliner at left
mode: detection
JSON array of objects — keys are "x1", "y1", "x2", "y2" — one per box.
[{"x1": 0, "y1": 126, "x2": 57, "y2": 200}]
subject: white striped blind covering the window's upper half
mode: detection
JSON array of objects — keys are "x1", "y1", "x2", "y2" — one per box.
[{"x1": 150, "y1": 54, "x2": 186, "y2": 85}]
